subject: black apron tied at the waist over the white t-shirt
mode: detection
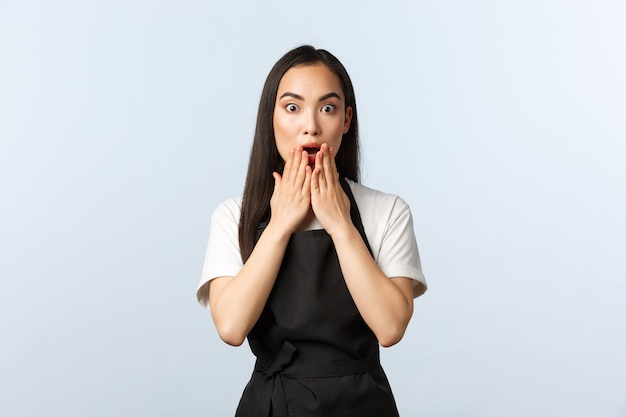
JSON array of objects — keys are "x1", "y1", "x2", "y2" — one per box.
[{"x1": 236, "y1": 178, "x2": 398, "y2": 417}]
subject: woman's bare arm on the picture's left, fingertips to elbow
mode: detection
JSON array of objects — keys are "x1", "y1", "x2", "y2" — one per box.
[{"x1": 209, "y1": 148, "x2": 311, "y2": 346}]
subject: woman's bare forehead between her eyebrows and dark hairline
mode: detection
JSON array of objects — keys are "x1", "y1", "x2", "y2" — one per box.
[{"x1": 277, "y1": 64, "x2": 344, "y2": 98}]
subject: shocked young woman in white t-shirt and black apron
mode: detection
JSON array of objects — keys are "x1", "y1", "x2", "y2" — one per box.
[{"x1": 197, "y1": 46, "x2": 426, "y2": 417}]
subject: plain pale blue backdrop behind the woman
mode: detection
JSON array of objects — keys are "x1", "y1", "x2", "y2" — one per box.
[{"x1": 0, "y1": 0, "x2": 626, "y2": 417}]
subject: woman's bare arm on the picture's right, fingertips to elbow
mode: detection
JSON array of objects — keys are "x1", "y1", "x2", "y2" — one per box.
[{"x1": 311, "y1": 145, "x2": 413, "y2": 346}]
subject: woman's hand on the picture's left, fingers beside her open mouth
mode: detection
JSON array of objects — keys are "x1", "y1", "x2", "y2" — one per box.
[{"x1": 270, "y1": 146, "x2": 312, "y2": 234}]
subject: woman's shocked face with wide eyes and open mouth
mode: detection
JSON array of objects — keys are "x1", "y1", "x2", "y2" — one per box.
[{"x1": 274, "y1": 64, "x2": 352, "y2": 166}]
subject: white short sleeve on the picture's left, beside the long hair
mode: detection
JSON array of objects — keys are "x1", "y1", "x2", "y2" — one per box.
[{"x1": 196, "y1": 198, "x2": 243, "y2": 308}]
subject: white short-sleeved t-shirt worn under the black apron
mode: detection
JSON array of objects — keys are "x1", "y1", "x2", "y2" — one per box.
[{"x1": 197, "y1": 179, "x2": 426, "y2": 308}]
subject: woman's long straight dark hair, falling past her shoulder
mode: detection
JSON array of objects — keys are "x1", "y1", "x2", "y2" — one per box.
[{"x1": 239, "y1": 45, "x2": 360, "y2": 262}]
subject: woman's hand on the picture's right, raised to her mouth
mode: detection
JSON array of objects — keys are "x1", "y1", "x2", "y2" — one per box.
[{"x1": 311, "y1": 143, "x2": 352, "y2": 236}]
